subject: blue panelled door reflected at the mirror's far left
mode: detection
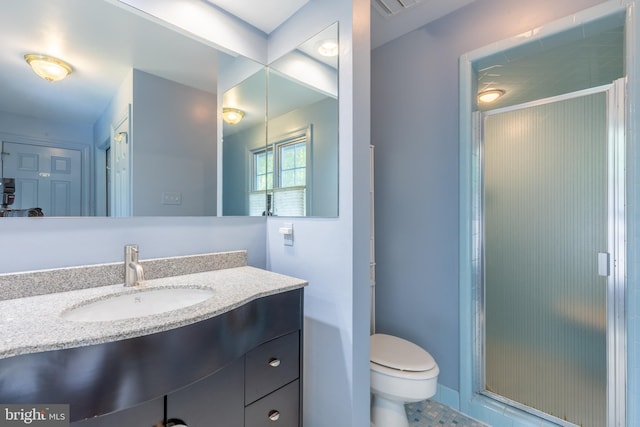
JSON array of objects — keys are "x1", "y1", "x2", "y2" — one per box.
[{"x1": 2, "y1": 141, "x2": 82, "y2": 216}]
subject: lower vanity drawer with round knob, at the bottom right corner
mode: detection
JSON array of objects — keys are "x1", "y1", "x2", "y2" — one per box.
[{"x1": 244, "y1": 380, "x2": 300, "y2": 427}]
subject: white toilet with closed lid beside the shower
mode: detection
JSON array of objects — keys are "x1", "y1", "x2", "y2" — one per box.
[{"x1": 369, "y1": 334, "x2": 440, "y2": 427}]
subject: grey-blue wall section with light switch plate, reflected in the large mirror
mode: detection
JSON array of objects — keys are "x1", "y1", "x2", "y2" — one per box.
[{"x1": 131, "y1": 70, "x2": 218, "y2": 216}]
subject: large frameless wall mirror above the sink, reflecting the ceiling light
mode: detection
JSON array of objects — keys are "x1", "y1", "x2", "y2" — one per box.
[{"x1": 0, "y1": 0, "x2": 266, "y2": 216}]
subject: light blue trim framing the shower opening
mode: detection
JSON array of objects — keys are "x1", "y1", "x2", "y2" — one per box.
[{"x1": 459, "y1": 0, "x2": 640, "y2": 427}]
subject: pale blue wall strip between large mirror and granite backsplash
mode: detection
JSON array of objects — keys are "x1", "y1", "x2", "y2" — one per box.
[{"x1": 0, "y1": 217, "x2": 266, "y2": 273}]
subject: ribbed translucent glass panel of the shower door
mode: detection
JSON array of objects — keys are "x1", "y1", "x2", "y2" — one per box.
[{"x1": 484, "y1": 93, "x2": 607, "y2": 427}]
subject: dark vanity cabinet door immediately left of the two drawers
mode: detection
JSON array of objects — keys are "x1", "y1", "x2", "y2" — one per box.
[{"x1": 167, "y1": 357, "x2": 244, "y2": 427}]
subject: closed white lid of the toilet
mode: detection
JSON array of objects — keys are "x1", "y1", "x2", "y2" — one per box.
[{"x1": 370, "y1": 334, "x2": 436, "y2": 372}]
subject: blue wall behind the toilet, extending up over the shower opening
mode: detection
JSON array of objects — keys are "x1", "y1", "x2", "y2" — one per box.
[{"x1": 371, "y1": 0, "x2": 600, "y2": 398}]
